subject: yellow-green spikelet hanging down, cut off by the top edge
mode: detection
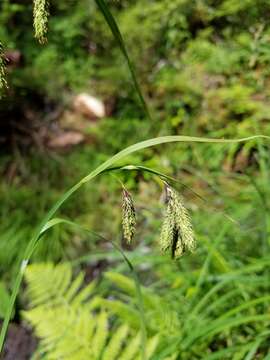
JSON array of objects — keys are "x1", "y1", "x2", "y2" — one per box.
[{"x1": 33, "y1": 0, "x2": 49, "y2": 44}]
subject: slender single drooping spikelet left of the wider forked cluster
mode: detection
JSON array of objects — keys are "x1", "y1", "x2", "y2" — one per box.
[{"x1": 122, "y1": 189, "x2": 136, "y2": 244}]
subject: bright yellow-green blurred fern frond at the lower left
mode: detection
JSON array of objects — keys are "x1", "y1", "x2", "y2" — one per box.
[{"x1": 23, "y1": 264, "x2": 158, "y2": 360}]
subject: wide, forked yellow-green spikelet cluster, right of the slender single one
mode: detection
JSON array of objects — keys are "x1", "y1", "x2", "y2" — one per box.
[{"x1": 160, "y1": 184, "x2": 195, "y2": 258}]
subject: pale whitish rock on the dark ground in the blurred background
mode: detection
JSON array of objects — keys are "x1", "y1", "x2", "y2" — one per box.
[{"x1": 73, "y1": 93, "x2": 106, "y2": 120}]
